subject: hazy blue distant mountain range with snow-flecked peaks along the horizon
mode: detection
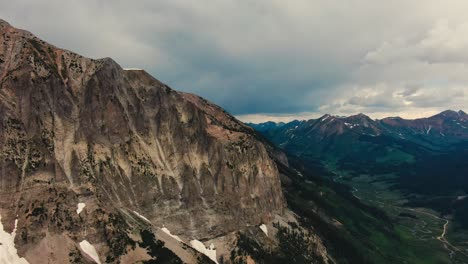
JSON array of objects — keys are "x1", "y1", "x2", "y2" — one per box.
[{"x1": 248, "y1": 110, "x2": 468, "y2": 155}]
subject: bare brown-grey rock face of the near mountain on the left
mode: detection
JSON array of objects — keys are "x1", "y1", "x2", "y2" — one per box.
[{"x1": 0, "y1": 20, "x2": 285, "y2": 263}]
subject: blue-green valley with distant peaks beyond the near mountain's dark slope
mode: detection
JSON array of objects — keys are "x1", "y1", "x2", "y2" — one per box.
[{"x1": 250, "y1": 110, "x2": 468, "y2": 263}]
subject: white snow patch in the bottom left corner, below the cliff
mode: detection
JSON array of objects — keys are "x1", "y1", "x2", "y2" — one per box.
[{"x1": 0, "y1": 215, "x2": 29, "y2": 264}]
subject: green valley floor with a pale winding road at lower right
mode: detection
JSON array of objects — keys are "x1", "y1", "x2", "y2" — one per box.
[{"x1": 328, "y1": 164, "x2": 468, "y2": 263}]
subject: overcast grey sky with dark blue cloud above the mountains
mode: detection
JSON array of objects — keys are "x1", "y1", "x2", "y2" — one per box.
[{"x1": 0, "y1": 0, "x2": 468, "y2": 122}]
